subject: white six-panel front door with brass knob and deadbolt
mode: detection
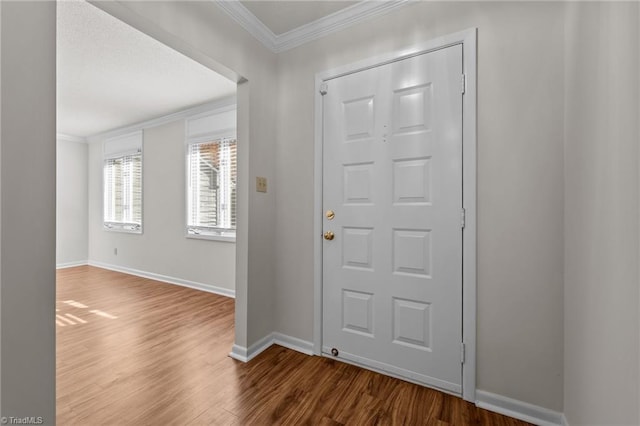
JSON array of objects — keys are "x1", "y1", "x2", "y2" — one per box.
[{"x1": 322, "y1": 45, "x2": 463, "y2": 393}]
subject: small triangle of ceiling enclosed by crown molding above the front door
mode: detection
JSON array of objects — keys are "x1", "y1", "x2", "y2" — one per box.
[{"x1": 240, "y1": 0, "x2": 358, "y2": 35}]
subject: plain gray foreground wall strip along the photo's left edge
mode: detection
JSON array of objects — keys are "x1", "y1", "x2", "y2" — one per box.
[{"x1": 0, "y1": 2, "x2": 56, "y2": 425}]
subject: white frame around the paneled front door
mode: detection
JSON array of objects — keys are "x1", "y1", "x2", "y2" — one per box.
[{"x1": 313, "y1": 28, "x2": 477, "y2": 403}]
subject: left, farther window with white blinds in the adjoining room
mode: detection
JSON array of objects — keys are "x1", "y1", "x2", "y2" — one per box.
[{"x1": 103, "y1": 132, "x2": 142, "y2": 233}]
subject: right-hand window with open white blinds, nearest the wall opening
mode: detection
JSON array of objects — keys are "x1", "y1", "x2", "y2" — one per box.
[{"x1": 187, "y1": 138, "x2": 238, "y2": 237}]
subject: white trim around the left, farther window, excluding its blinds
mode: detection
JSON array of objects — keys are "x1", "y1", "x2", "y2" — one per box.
[{"x1": 101, "y1": 130, "x2": 145, "y2": 235}]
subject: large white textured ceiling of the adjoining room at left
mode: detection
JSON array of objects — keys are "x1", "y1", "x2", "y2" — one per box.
[{"x1": 57, "y1": 1, "x2": 236, "y2": 137}]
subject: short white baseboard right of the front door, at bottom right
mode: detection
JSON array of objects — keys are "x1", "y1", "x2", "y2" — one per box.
[{"x1": 476, "y1": 390, "x2": 566, "y2": 426}]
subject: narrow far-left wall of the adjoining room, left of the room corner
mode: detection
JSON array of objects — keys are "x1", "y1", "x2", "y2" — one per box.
[{"x1": 56, "y1": 140, "x2": 89, "y2": 267}]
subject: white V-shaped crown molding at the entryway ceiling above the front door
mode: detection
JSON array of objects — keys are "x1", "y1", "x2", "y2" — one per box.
[{"x1": 214, "y1": 0, "x2": 410, "y2": 53}]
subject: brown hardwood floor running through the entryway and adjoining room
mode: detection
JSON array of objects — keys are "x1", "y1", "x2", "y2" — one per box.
[{"x1": 56, "y1": 266, "x2": 527, "y2": 426}]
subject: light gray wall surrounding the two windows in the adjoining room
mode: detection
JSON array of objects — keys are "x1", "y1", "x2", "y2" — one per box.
[{"x1": 89, "y1": 120, "x2": 235, "y2": 292}]
